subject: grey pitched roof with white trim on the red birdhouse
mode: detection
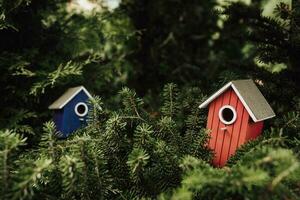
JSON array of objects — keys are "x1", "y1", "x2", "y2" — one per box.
[{"x1": 199, "y1": 79, "x2": 275, "y2": 122}]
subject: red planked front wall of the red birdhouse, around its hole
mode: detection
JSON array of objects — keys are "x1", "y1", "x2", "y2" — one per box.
[{"x1": 207, "y1": 88, "x2": 249, "y2": 166}]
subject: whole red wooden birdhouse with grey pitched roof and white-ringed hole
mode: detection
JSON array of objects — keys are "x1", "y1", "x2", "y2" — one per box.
[{"x1": 199, "y1": 80, "x2": 275, "y2": 167}]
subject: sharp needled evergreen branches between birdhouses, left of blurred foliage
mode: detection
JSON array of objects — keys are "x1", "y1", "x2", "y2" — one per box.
[{"x1": 3, "y1": 86, "x2": 213, "y2": 199}]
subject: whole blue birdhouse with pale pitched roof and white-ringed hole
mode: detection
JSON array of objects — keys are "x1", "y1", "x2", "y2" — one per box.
[{"x1": 49, "y1": 86, "x2": 92, "y2": 138}]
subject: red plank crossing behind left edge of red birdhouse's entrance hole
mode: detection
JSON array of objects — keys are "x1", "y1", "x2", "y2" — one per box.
[{"x1": 213, "y1": 90, "x2": 231, "y2": 166}]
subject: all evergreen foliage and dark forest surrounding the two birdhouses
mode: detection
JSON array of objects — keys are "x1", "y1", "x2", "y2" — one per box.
[{"x1": 0, "y1": 0, "x2": 300, "y2": 199}]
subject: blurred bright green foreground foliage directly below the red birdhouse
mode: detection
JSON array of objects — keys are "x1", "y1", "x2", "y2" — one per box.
[{"x1": 170, "y1": 147, "x2": 300, "y2": 199}]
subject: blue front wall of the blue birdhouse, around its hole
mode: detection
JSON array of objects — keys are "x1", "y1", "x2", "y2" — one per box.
[{"x1": 63, "y1": 91, "x2": 89, "y2": 137}]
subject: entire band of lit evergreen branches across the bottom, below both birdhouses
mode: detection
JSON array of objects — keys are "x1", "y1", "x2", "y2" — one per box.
[{"x1": 4, "y1": 79, "x2": 300, "y2": 199}]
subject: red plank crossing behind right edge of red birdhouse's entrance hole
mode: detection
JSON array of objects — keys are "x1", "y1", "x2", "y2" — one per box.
[{"x1": 219, "y1": 89, "x2": 239, "y2": 166}]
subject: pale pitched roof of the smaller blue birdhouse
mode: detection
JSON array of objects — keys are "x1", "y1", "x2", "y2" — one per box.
[{"x1": 48, "y1": 86, "x2": 92, "y2": 110}]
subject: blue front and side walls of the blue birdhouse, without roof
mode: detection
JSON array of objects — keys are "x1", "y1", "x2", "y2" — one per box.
[{"x1": 54, "y1": 91, "x2": 89, "y2": 138}]
